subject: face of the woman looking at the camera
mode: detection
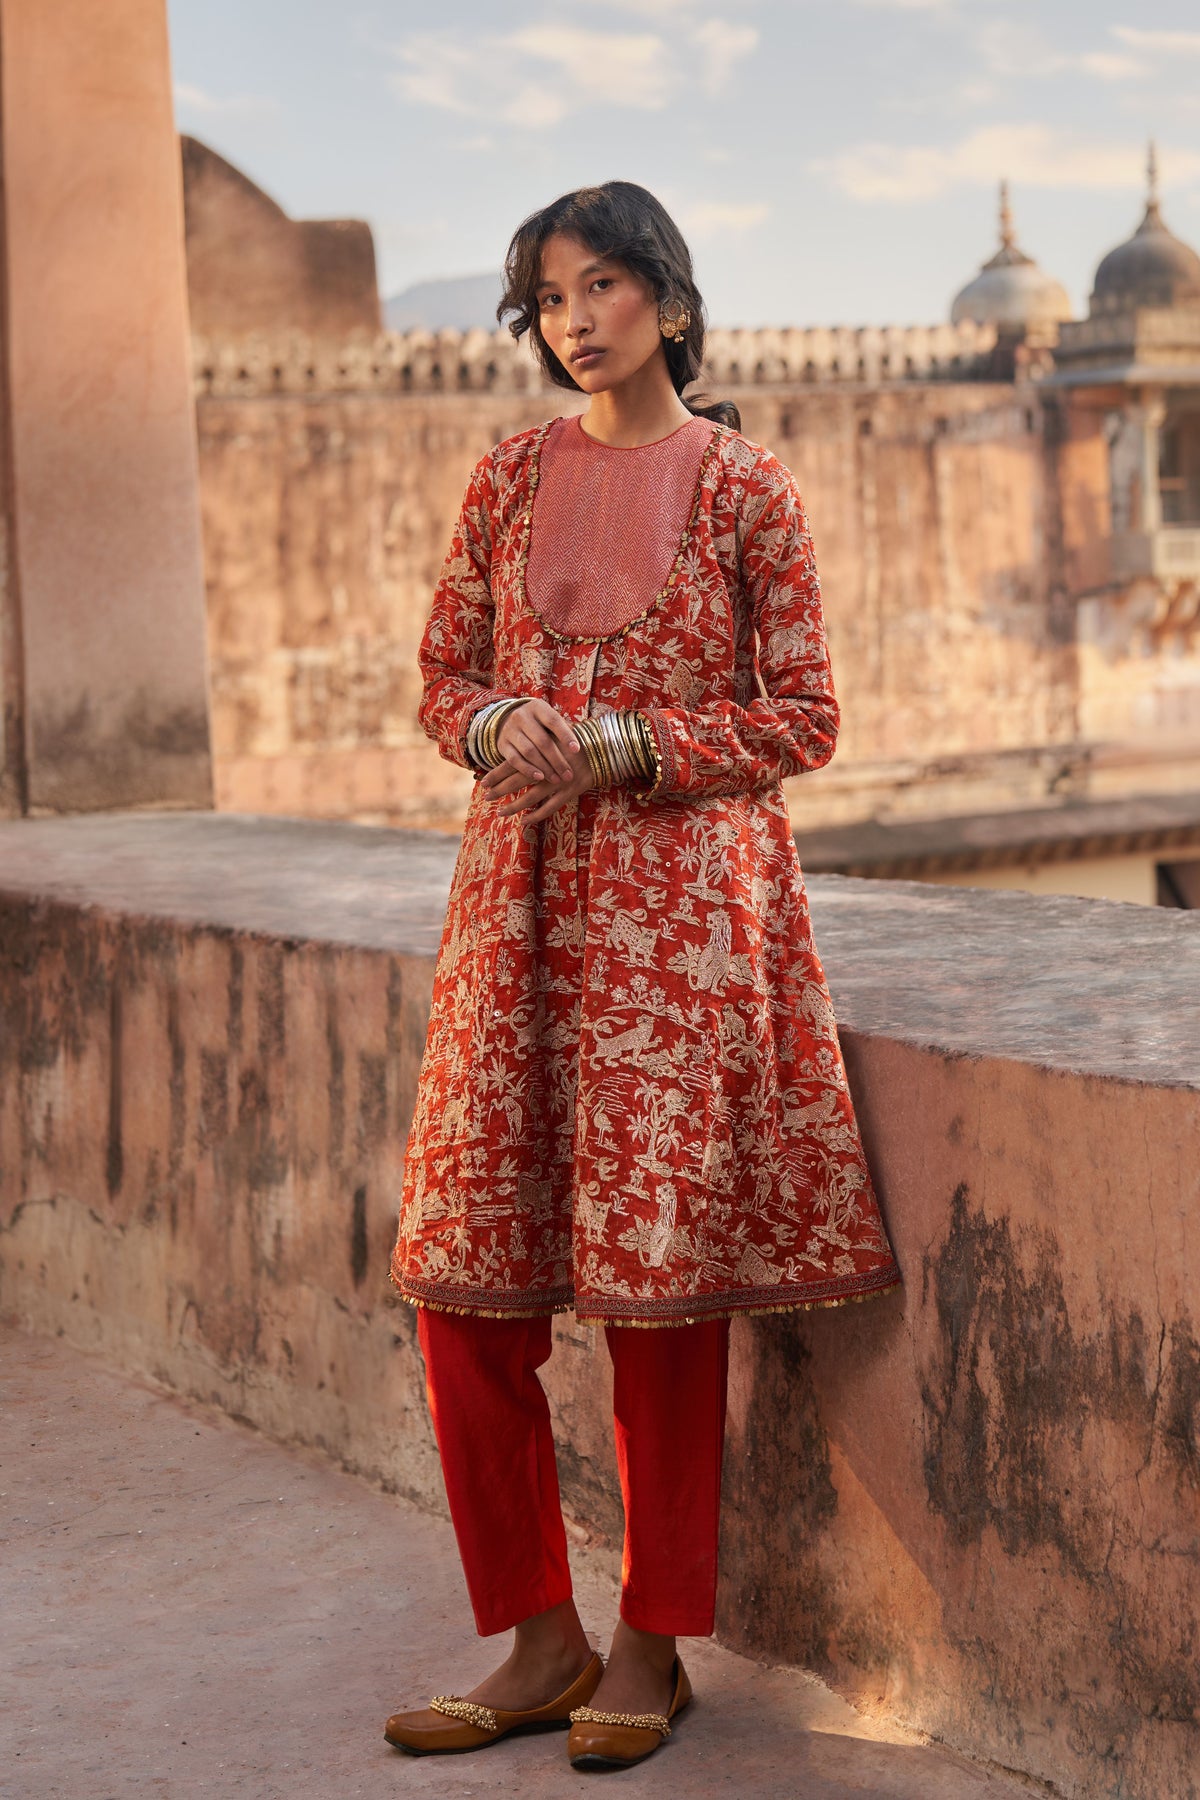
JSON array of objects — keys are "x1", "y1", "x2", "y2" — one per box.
[{"x1": 538, "y1": 232, "x2": 666, "y2": 394}]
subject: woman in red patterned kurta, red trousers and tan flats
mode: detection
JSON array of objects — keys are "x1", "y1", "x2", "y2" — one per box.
[{"x1": 387, "y1": 182, "x2": 900, "y2": 1768}]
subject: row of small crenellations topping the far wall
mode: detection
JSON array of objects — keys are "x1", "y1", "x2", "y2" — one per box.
[{"x1": 193, "y1": 322, "x2": 995, "y2": 398}]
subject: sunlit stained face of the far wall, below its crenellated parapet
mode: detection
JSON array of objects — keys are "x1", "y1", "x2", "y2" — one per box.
[{"x1": 198, "y1": 383, "x2": 1101, "y2": 824}]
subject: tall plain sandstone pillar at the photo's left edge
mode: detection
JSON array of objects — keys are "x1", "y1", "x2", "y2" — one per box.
[{"x1": 0, "y1": 0, "x2": 212, "y2": 814}]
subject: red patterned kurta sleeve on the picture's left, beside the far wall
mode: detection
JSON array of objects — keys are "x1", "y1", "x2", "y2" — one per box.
[{"x1": 417, "y1": 455, "x2": 521, "y2": 769}]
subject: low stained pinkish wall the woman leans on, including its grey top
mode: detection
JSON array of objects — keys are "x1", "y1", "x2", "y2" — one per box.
[{"x1": 0, "y1": 814, "x2": 1200, "y2": 1800}]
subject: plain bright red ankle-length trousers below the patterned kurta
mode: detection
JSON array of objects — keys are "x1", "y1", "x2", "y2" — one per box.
[{"x1": 417, "y1": 1307, "x2": 729, "y2": 1638}]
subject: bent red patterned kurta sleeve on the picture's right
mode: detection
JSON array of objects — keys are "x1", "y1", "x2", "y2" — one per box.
[{"x1": 640, "y1": 457, "x2": 840, "y2": 799}]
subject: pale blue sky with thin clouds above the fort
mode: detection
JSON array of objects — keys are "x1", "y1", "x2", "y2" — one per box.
[{"x1": 169, "y1": 0, "x2": 1200, "y2": 326}]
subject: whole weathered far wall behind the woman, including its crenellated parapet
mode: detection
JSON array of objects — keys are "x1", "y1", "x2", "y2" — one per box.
[{"x1": 194, "y1": 326, "x2": 1200, "y2": 826}]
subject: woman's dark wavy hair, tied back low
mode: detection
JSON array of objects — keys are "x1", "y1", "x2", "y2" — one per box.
[{"x1": 497, "y1": 182, "x2": 741, "y2": 432}]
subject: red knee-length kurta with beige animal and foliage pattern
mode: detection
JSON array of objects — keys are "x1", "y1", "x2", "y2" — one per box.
[{"x1": 390, "y1": 419, "x2": 900, "y2": 1325}]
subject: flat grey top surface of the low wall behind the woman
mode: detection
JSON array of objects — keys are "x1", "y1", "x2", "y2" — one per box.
[{"x1": 0, "y1": 812, "x2": 1200, "y2": 1087}]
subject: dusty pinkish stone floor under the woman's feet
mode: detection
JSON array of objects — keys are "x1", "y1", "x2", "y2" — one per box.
[{"x1": 0, "y1": 1332, "x2": 1027, "y2": 1800}]
